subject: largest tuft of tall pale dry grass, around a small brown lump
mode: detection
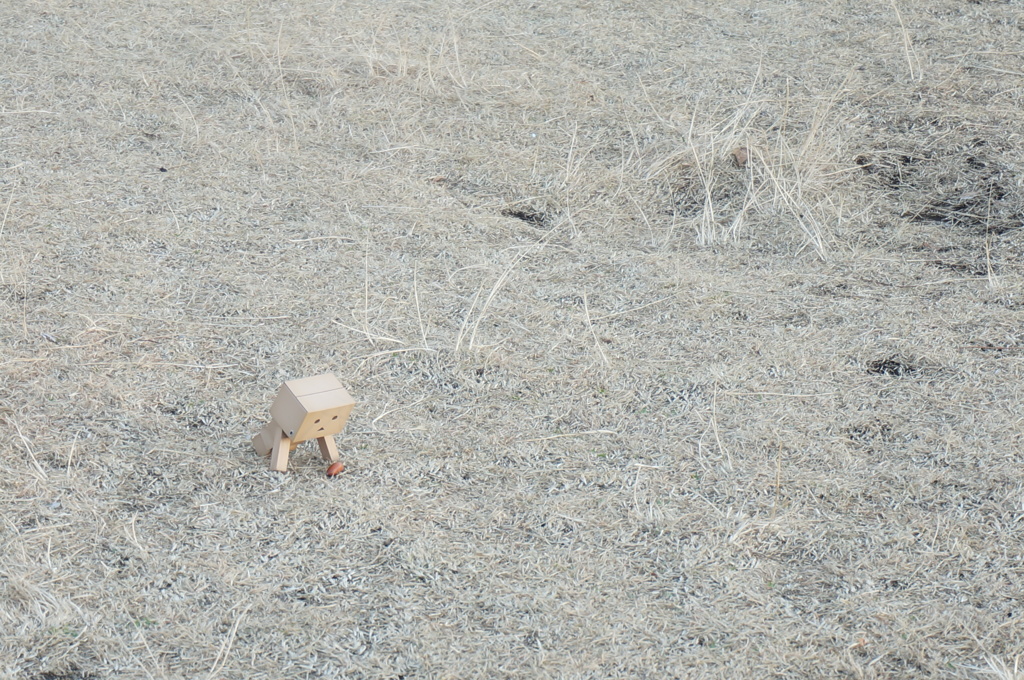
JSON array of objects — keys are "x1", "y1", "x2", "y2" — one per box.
[{"x1": 647, "y1": 74, "x2": 851, "y2": 260}]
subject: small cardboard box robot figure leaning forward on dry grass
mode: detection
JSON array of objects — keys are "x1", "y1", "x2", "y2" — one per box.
[{"x1": 253, "y1": 373, "x2": 355, "y2": 474}]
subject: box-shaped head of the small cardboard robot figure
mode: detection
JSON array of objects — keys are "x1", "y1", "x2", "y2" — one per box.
[{"x1": 270, "y1": 373, "x2": 355, "y2": 441}]
